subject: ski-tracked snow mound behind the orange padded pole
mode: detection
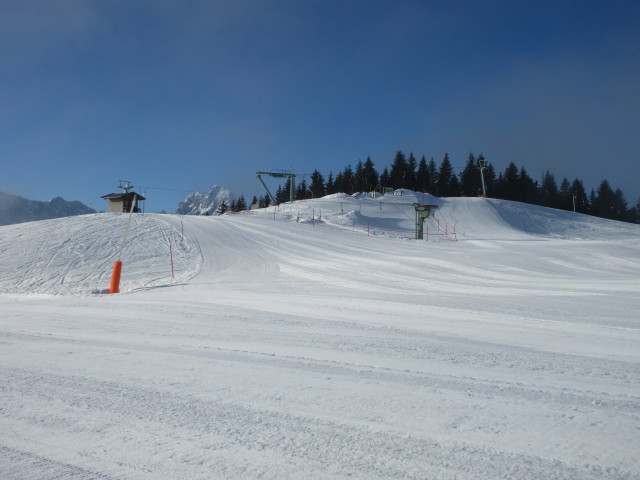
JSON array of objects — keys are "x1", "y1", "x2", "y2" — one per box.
[{"x1": 0, "y1": 213, "x2": 201, "y2": 295}]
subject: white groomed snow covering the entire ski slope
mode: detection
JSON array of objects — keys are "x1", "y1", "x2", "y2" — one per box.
[{"x1": 0, "y1": 191, "x2": 640, "y2": 480}]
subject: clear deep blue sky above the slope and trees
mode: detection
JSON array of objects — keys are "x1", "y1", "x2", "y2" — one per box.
[{"x1": 0, "y1": 0, "x2": 640, "y2": 211}]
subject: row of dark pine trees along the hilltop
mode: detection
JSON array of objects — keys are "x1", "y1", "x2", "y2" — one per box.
[{"x1": 242, "y1": 151, "x2": 640, "y2": 223}]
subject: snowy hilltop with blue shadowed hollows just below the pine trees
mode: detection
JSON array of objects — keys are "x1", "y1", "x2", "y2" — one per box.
[{"x1": 252, "y1": 190, "x2": 640, "y2": 241}]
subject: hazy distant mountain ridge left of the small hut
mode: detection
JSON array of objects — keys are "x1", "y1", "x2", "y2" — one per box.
[{"x1": 0, "y1": 192, "x2": 96, "y2": 225}]
